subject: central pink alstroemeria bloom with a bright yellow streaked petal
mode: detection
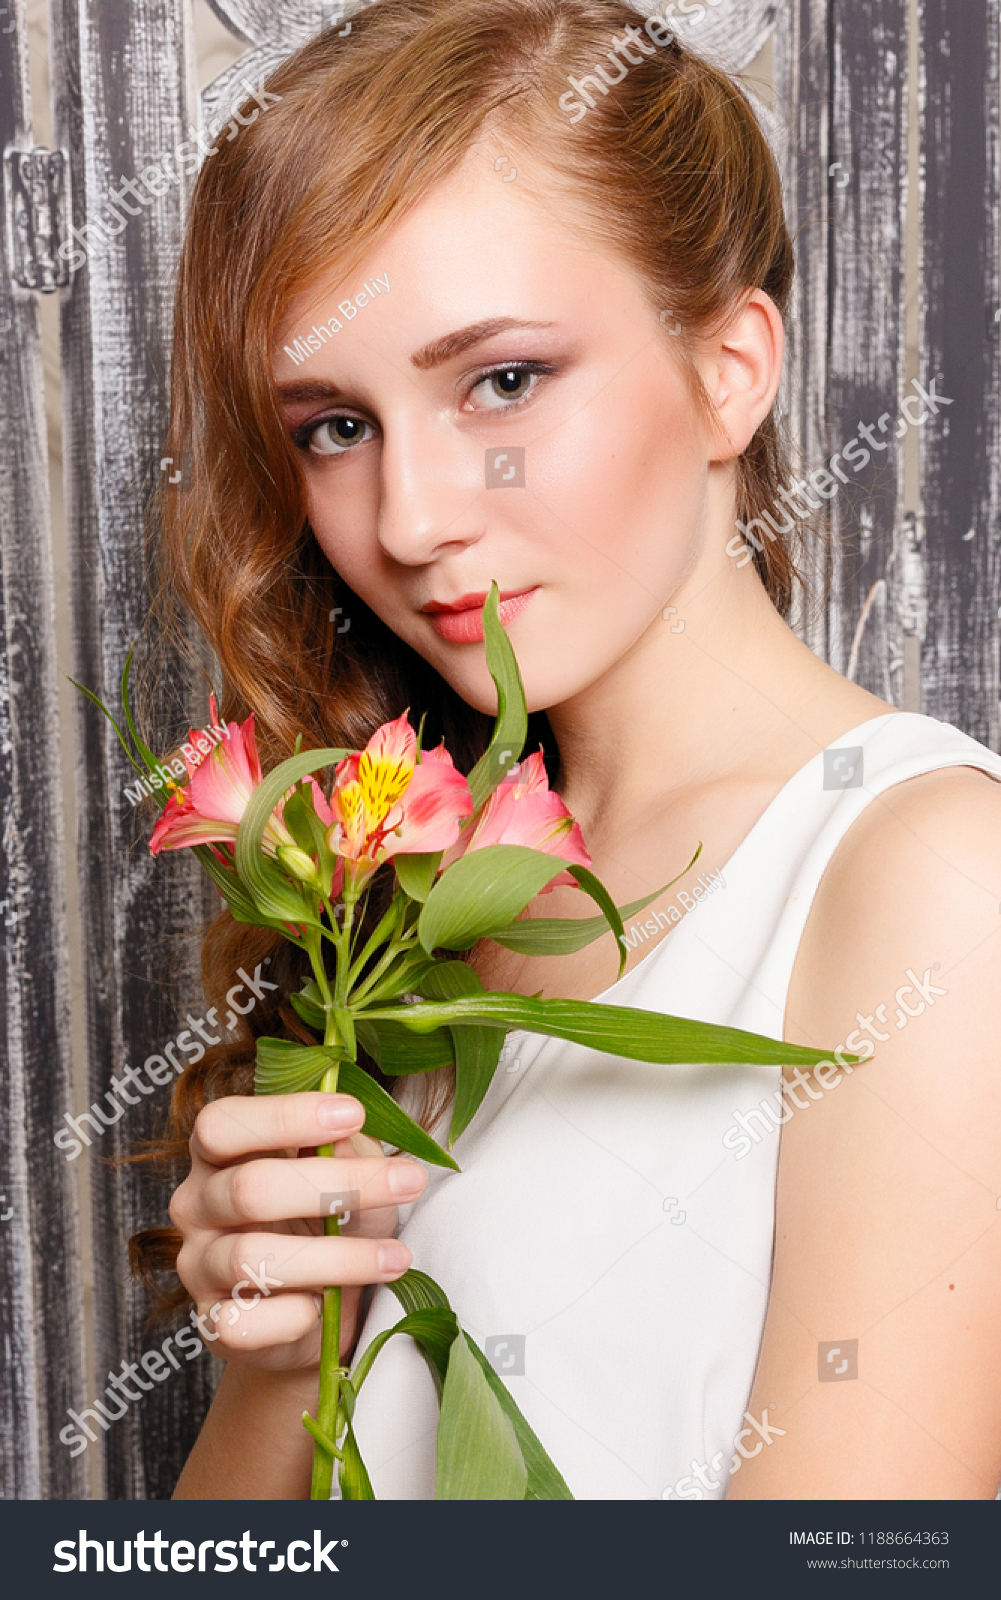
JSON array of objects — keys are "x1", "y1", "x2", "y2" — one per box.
[{"x1": 326, "y1": 712, "x2": 473, "y2": 885}]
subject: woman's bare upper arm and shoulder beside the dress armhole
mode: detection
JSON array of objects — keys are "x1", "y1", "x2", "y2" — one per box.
[{"x1": 728, "y1": 768, "x2": 1001, "y2": 1499}]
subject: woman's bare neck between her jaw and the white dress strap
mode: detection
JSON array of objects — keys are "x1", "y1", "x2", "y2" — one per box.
[{"x1": 548, "y1": 560, "x2": 889, "y2": 837}]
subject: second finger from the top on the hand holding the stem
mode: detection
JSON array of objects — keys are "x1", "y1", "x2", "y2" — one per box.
[{"x1": 198, "y1": 1155, "x2": 427, "y2": 1230}]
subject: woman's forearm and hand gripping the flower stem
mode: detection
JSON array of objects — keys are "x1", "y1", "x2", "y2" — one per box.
[{"x1": 171, "y1": 1094, "x2": 427, "y2": 1499}]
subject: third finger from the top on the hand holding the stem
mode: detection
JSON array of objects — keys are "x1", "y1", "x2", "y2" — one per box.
[{"x1": 192, "y1": 1234, "x2": 413, "y2": 1309}]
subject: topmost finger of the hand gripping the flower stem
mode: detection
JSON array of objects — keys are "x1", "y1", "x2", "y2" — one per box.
[{"x1": 190, "y1": 1093, "x2": 365, "y2": 1166}]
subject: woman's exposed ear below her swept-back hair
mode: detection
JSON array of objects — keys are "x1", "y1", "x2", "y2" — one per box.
[{"x1": 696, "y1": 290, "x2": 785, "y2": 461}]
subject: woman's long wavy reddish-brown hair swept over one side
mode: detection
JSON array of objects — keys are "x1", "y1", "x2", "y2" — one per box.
[{"x1": 133, "y1": 0, "x2": 795, "y2": 1304}]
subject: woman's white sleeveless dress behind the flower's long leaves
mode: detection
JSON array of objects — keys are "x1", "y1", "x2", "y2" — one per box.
[{"x1": 342, "y1": 712, "x2": 1001, "y2": 1499}]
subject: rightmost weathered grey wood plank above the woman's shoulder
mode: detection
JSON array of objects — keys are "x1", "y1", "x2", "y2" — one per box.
[{"x1": 921, "y1": 0, "x2": 1001, "y2": 749}]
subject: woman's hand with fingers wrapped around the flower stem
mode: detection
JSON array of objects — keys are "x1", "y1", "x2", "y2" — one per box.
[{"x1": 169, "y1": 1093, "x2": 427, "y2": 1371}]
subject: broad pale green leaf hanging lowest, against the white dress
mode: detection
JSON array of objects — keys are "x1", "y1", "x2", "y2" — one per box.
[{"x1": 435, "y1": 1339, "x2": 528, "y2": 1501}]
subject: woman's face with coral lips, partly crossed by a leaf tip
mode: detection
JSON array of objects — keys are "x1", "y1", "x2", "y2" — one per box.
[{"x1": 275, "y1": 147, "x2": 713, "y2": 712}]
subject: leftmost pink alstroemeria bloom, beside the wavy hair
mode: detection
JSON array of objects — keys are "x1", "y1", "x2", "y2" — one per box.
[{"x1": 149, "y1": 696, "x2": 333, "y2": 856}]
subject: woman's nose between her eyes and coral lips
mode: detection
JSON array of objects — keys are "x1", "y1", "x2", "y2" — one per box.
[{"x1": 379, "y1": 416, "x2": 485, "y2": 566}]
